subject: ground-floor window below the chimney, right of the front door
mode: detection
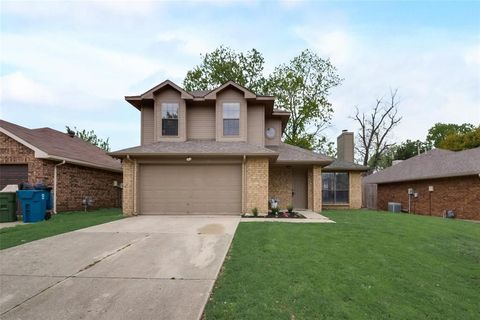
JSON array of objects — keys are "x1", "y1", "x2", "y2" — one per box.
[{"x1": 322, "y1": 172, "x2": 349, "y2": 204}]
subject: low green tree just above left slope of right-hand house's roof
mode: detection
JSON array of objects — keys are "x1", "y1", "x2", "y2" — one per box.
[{"x1": 377, "y1": 140, "x2": 431, "y2": 169}]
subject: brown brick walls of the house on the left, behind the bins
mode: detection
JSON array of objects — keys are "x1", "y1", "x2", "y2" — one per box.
[{"x1": 0, "y1": 133, "x2": 122, "y2": 211}]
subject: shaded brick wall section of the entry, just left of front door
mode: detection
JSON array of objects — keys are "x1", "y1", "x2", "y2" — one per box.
[{"x1": 268, "y1": 166, "x2": 293, "y2": 209}]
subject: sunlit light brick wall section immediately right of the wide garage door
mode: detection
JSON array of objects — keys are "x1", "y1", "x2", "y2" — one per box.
[{"x1": 245, "y1": 158, "x2": 268, "y2": 213}]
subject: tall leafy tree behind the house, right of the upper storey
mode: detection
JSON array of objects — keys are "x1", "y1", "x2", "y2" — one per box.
[{"x1": 265, "y1": 50, "x2": 342, "y2": 152}]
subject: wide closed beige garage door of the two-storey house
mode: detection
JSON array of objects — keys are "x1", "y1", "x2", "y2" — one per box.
[{"x1": 139, "y1": 164, "x2": 242, "y2": 214}]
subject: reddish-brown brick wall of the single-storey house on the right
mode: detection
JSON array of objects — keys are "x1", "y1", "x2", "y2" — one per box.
[{"x1": 377, "y1": 175, "x2": 480, "y2": 220}]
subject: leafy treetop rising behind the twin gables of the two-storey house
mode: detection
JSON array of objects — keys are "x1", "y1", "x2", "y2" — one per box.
[{"x1": 183, "y1": 46, "x2": 265, "y2": 93}]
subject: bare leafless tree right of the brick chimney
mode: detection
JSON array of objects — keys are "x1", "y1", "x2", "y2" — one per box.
[{"x1": 352, "y1": 90, "x2": 402, "y2": 169}]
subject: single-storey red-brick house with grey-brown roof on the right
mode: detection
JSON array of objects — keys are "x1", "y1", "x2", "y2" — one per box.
[{"x1": 363, "y1": 148, "x2": 480, "y2": 220}]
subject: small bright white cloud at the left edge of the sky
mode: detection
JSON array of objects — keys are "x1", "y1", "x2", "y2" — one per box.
[{"x1": 0, "y1": 72, "x2": 55, "y2": 105}]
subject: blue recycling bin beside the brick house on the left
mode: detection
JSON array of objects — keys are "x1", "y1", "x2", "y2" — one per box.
[{"x1": 17, "y1": 190, "x2": 51, "y2": 222}]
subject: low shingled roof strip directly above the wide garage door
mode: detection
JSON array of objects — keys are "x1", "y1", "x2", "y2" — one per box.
[{"x1": 110, "y1": 140, "x2": 277, "y2": 158}]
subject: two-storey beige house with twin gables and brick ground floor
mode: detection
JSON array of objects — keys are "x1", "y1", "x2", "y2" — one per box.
[{"x1": 111, "y1": 80, "x2": 366, "y2": 215}]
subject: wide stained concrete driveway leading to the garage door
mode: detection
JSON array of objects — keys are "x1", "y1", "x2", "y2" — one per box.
[{"x1": 0, "y1": 216, "x2": 240, "y2": 320}]
